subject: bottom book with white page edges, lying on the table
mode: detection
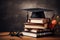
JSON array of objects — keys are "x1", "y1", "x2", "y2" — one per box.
[{"x1": 22, "y1": 32, "x2": 52, "y2": 37}]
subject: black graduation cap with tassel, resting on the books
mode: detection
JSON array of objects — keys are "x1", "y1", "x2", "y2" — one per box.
[{"x1": 22, "y1": 8, "x2": 53, "y2": 19}]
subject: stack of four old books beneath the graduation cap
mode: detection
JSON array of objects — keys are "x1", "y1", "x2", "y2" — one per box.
[{"x1": 22, "y1": 18, "x2": 52, "y2": 37}]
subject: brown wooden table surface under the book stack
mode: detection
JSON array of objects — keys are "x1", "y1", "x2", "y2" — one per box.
[{"x1": 0, "y1": 32, "x2": 60, "y2": 40}]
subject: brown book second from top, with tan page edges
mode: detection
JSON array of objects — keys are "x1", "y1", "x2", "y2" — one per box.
[{"x1": 24, "y1": 23, "x2": 48, "y2": 29}]
